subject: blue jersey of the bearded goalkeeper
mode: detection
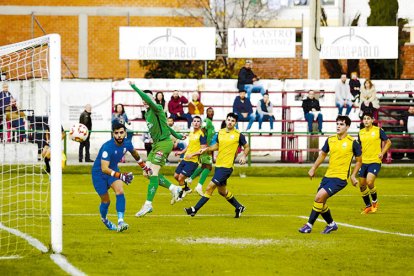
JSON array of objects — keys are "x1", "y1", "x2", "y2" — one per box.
[{"x1": 92, "y1": 138, "x2": 134, "y2": 173}]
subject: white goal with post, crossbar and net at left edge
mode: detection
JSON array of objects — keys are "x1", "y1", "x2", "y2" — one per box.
[{"x1": 0, "y1": 35, "x2": 62, "y2": 258}]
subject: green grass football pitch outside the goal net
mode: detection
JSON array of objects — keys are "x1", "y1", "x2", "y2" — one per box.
[{"x1": 0, "y1": 174, "x2": 414, "y2": 275}]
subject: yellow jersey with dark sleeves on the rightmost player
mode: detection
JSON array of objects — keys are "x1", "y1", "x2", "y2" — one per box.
[{"x1": 358, "y1": 126, "x2": 388, "y2": 164}]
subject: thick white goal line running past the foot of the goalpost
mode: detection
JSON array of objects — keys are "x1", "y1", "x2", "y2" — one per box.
[{"x1": 0, "y1": 222, "x2": 86, "y2": 276}]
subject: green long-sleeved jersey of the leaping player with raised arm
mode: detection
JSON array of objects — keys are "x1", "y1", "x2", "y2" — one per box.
[{"x1": 131, "y1": 84, "x2": 183, "y2": 143}]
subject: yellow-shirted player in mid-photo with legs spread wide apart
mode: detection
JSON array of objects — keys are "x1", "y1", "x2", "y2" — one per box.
[{"x1": 184, "y1": 113, "x2": 250, "y2": 218}]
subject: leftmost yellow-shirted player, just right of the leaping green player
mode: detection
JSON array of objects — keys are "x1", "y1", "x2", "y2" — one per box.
[{"x1": 174, "y1": 116, "x2": 207, "y2": 197}]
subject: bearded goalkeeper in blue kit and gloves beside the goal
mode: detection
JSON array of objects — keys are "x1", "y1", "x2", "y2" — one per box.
[{"x1": 92, "y1": 124, "x2": 152, "y2": 232}]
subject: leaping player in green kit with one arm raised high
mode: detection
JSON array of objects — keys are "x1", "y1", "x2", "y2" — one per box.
[{"x1": 129, "y1": 81, "x2": 186, "y2": 217}]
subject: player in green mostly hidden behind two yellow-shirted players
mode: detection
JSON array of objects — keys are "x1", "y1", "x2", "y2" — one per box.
[{"x1": 185, "y1": 107, "x2": 216, "y2": 196}]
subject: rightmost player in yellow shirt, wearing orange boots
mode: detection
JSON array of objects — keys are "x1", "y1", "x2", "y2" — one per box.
[{"x1": 358, "y1": 113, "x2": 391, "y2": 214}]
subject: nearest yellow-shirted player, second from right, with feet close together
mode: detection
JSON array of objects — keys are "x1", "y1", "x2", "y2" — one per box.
[{"x1": 299, "y1": 115, "x2": 362, "y2": 234}]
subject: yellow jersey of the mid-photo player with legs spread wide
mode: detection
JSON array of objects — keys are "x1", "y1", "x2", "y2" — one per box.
[{"x1": 216, "y1": 128, "x2": 247, "y2": 168}]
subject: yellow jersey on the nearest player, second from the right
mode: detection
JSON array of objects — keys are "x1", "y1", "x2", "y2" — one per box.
[{"x1": 322, "y1": 135, "x2": 361, "y2": 180}]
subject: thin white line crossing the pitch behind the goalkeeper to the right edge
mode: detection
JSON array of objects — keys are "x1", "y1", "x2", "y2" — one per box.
[{"x1": 64, "y1": 214, "x2": 414, "y2": 238}]
